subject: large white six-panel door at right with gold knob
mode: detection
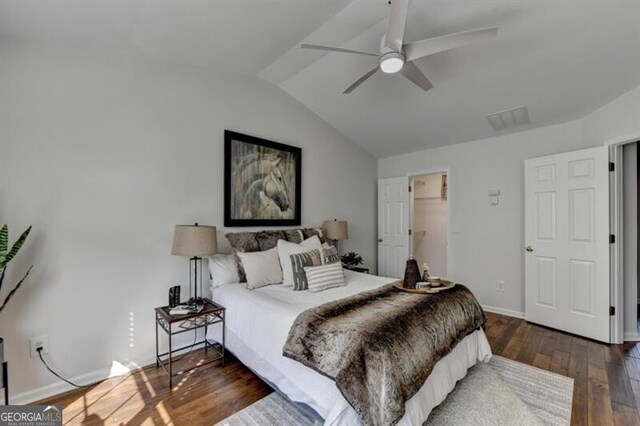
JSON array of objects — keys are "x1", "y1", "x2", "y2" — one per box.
[{"x1": 524, "y1": 146, "x2": 610, "y2": 342}]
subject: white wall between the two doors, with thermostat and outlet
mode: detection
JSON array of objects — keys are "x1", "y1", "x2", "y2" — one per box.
[{"x1": 378, "y1": 87, "x2": 640, "y2": 320}]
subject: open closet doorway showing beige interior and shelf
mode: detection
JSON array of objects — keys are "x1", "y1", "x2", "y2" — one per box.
[{"x1": 409, "y1": 172, "x2": 449, "y2": 277}]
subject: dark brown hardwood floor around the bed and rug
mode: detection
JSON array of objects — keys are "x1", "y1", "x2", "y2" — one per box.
[{"x1": 40, "y1": 313, "x2": 640, "y2": 426}]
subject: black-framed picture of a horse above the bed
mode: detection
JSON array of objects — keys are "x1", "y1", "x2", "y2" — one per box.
[{"x1": 224, "y1": 130, "x2": 302, "y2": 226}]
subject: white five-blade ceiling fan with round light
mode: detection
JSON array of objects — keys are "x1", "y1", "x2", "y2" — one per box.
[{"x1": 300, "y1": 0, "x2": 498, "y2": 93}]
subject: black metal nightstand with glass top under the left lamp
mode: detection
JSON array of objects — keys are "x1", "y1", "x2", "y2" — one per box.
[{"x1": 156, "y1": 299, "x2": 226, "y2": 387}]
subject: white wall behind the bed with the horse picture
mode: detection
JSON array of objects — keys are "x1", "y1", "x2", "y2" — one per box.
[{"x1": 0, "y1": 39, "x2": 376, "y2": 402}]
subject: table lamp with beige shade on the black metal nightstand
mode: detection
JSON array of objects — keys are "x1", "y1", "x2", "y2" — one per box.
[{"x1": 171, "y1": 223, "x2": 218, "y2": 305}]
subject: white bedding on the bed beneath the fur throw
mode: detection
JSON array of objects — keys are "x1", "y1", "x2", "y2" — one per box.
[{"x1": 207, "y1": 270, "x2": 491, "y2": 425}]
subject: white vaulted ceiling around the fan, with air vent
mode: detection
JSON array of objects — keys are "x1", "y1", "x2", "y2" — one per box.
[{"x1": 0, "y1": 0, "x2": 640, "y2": 157}]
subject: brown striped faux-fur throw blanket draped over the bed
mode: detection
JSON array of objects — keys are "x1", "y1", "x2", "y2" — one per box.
[{"x1": 283, "y1": 284, "x2": 486, "y2": 425}]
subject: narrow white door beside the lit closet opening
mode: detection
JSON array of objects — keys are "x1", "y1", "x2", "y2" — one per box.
[{"x1": 378, "y1": 176, "x2": 409, "y2": 278}]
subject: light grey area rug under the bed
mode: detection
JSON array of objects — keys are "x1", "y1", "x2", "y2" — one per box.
[{"x1": 218, "y1": 355, "x2": 573, "y2": 426}]
